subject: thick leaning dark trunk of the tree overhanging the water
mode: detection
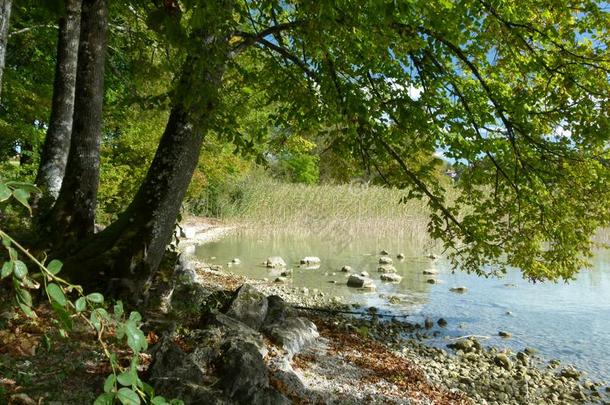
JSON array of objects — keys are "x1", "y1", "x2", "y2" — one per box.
[{"x1": 64, "y1": 53, "x2": 224, "y2": 302}]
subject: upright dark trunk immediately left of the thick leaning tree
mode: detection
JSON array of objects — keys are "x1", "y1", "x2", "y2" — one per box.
[{"x1": 45, "y1": 0, "x2": 108, "y2": 246}]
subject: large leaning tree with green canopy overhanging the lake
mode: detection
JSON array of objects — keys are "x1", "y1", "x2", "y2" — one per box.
[{"x1": 28, "y1": 0, "x2": 610, "y2": 292}]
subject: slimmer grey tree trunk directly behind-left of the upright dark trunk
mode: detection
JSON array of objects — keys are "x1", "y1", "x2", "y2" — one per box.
[{"x1": 36, "y1": 0, "x2": 82, "y2": 200}]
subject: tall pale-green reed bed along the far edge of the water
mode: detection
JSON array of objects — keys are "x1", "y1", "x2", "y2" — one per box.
[{"x1": 192, "y1": 172, "x2": 428, "y2": 239}]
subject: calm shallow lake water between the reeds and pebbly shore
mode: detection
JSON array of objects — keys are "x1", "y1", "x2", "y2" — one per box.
[{"x1": 197, "y1": 229, "x2": 610, "y2": 381}]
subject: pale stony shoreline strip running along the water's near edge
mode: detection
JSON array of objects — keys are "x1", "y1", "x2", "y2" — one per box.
[{"x1": 180, "y1": 218, "x2": 610, "y2": 405}]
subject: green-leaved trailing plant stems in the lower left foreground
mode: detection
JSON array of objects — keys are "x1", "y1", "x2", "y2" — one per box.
[{"x1": 0, "y1": 181, "x2": 183, "y2": 405}]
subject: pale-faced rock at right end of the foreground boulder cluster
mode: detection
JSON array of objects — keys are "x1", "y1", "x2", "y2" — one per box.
[{"x1": 264, "y1": 317, "x2": 320, "y2": 359}]
